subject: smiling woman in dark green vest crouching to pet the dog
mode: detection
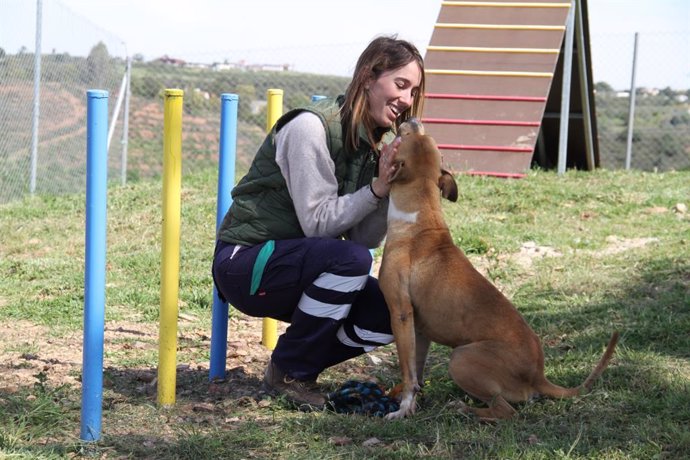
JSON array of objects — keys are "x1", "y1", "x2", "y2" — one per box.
[{"x1": 213, "y1": 37, "x2": 424, "y2": 409}]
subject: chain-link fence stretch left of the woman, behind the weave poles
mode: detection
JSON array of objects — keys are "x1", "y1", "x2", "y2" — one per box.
[{"x1": 0, "y1": 0, "x2": 366, "y2": 203}]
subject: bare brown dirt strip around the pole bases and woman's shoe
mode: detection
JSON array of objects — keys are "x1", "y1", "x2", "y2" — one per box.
[{"x1": 0, "y1": 310, "x2": 388, "y2": 413}]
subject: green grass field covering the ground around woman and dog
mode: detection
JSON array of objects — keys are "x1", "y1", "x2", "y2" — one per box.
[{"x1": 0, "y1": 170, "x2": 690, "y2": 459}]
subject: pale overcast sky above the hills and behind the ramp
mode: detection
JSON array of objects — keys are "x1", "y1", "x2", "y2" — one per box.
[{"x1": 0, "y1": 0, "x2": 690, "y2": 88}]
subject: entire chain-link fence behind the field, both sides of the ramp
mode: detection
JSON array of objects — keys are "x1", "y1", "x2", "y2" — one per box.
[{"x1": 0, "y1": 0, "x2": 690, "y2": 203}]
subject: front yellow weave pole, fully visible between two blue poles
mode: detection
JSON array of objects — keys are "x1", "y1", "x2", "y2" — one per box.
[{"x1": 158, "y1": 89, "x2": 184, "y2": 406}]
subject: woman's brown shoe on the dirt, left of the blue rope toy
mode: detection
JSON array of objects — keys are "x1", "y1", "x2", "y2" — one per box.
[{"x1": 263, "y1": 361, "x2": 326, "y2": 411}]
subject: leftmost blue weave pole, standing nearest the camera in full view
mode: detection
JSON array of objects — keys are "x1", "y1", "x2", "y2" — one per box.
[{"x1": 81, "y1": 90, "x2": 108, "y2": 441}]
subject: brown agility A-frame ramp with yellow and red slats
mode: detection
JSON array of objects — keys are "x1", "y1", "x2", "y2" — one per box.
[{"x1": 423, "y1": 0, "x2": 599, "y2": 177}]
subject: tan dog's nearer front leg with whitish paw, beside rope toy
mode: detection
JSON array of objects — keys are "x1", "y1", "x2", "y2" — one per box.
[{"x1": 386, "y1": 298, "x2": 419, "y2": 420}]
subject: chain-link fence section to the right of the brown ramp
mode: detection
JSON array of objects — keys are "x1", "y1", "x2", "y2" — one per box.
[{"x1": 591, "y1": 32, "x2": 690, "y2": 171}]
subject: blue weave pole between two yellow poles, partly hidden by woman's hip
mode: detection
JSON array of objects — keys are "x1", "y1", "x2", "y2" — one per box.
[{"x1": 209, "y1": 93, "x2": 239, "y2": 381}]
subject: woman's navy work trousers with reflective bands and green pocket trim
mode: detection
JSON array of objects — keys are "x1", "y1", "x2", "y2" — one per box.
[{"x1": 213, "y1": 238, "x2": 393, "y2": 380}]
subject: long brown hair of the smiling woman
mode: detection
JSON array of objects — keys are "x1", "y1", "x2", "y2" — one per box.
[{"x1": 340, "y1": 36, "x2": 424, "y2": 150}]
